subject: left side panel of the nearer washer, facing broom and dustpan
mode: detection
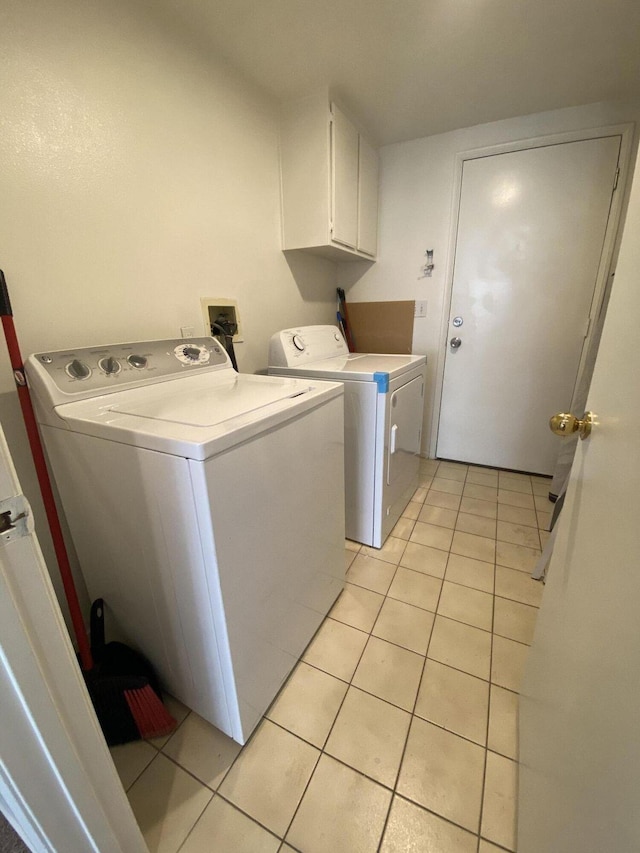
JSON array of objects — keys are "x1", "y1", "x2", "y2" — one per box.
[{"x1": 42, "y1": 427, "x2": 233, "y2": 734}]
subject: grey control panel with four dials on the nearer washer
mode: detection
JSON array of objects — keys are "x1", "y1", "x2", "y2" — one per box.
[{"x1": 27, "y1": 338, "x2": 232, "y2": 394}]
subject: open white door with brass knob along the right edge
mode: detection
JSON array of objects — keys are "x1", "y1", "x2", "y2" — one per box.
[{"x1": 518, "y1": 146, "x2": 640, "y2": 853}]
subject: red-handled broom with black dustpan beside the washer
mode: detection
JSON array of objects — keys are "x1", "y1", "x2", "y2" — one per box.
[{"x1": 0, "y1": 270, "x2": 177, "y2": 745}]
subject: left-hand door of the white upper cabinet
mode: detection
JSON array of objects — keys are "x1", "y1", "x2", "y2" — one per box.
[{"x1": 331, "y1": 105, "x2": 358, "y2": 249}]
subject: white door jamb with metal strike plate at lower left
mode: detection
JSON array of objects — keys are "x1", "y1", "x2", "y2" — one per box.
[{"x1": 0, "y1": 428, "x2": 147, "y2": 853}]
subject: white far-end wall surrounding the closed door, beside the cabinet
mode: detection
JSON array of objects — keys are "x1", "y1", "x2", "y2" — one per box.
[{"x1": 338, "y1": 102, "x2": 640, "y2": 454}]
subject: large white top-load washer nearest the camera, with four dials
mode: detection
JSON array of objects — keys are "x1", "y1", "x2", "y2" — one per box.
[{"x1": 26, "y1": 338, "x2": 344, "y2": 743}]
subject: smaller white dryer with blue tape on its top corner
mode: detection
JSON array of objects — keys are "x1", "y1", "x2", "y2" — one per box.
[{"x1": 269, "y1": 326, "x2": 426, "y2": 548}]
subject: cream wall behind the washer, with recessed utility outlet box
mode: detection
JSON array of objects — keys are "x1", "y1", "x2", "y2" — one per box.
[{"x1": 0, "y1": 0, "x2": 336, "y2": 624}]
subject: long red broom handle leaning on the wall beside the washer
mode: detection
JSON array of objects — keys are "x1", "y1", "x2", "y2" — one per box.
[{"x1": 0, "y1": 270, "x2": 93, "y2": 672}]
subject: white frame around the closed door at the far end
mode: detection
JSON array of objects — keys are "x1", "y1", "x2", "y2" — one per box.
[{"x1": 429, "y1": 123, "x2": 635, "y2": 459}]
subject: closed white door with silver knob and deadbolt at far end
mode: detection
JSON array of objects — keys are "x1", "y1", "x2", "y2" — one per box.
[{"x1": 437, "y1": 136, "x2": 621, "y2": 474}]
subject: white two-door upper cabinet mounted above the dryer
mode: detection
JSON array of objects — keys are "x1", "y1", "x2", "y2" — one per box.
[{"x1": 280, "y1": 93, "x2": 378, "y2": 260}]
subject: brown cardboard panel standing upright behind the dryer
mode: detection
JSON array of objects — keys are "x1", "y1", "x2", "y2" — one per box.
[{"x1": 347, "y1": 300, "x2": 415, "y2": 355}]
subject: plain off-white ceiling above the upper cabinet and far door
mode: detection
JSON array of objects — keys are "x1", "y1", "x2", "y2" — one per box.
[{"x1": 154, "y1": 0, "x2": 640, "y2": 145}]
